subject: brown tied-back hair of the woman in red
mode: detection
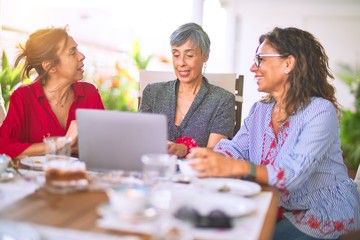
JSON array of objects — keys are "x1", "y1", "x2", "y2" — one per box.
[{"x1": 15, "y1": 26, "x2": 69, "y2": 84}]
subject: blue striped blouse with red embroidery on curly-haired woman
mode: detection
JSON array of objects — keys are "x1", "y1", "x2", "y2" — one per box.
[{"x1": 215, "y1": 98, "x2": 360, "y2": 238}]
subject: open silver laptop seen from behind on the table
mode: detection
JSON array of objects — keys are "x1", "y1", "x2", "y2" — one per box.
[{"x1": 76, "y1": 109, "x2": 167, "y2": 171}]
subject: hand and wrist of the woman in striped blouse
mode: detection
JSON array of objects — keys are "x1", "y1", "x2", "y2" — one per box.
[{"x1": 186, "y1": 148, "x2": 246, "y2": 177}]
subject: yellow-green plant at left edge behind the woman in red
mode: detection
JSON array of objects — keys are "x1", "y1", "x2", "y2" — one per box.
[{"x1": 0, "y1": 51, "x2": 30, "y2": 109}]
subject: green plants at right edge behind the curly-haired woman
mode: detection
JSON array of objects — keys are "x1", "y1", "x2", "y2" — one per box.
[{"x1": 336, "y1": 63, "x2": 360, "y2": 169}]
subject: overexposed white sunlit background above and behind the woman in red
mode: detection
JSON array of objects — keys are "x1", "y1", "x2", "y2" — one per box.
[{"x1": 1, "y1": 0, "x2": 197, "y2": 74}]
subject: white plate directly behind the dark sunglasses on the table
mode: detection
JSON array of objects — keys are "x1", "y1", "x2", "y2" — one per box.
[{"x1": 188, "y1": 193, "x2": 256, "y2": 217}]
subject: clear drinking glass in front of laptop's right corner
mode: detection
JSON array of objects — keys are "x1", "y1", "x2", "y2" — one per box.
[{"x1": 141, "y1": 153, "x2": 177, "y2": 186}]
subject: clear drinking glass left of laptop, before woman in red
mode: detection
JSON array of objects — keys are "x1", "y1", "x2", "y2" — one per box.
[{"x1": 43, "y1": 137, "x2": 71, "y2": 161}]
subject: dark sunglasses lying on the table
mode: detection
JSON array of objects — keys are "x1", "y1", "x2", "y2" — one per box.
[{"x1": 174, "y1": 205, "x2": 232, "y2": 228}]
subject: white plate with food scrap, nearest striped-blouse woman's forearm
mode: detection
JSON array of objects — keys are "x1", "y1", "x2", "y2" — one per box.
[{"x1": 194, "y1": 178, "x2": 261, "y2": 196}]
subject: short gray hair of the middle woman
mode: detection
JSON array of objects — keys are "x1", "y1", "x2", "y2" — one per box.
[{"x1": 170, "y1": 22, "x2": 210, "y2": 56}]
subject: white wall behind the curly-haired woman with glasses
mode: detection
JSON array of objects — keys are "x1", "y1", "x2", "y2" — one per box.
[{"x1": 222, "y1": 0, "x2": 360, "y2": 121}]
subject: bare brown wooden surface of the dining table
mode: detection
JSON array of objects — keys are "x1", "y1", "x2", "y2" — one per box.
[{"x1": 0, "y1": 186, "x2": 278, "y2": 239}]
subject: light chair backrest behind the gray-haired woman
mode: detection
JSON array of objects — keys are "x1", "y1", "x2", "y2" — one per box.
[{"x1": 139, "y1": 70, "x2": 244, "y2": 134}]
